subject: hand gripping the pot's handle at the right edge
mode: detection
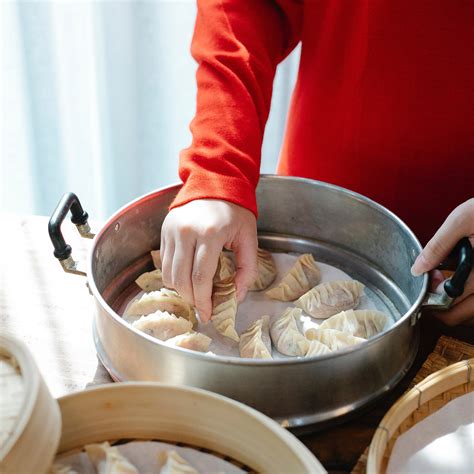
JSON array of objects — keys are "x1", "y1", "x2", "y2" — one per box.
[{"x1": 411, "y1": 198, "x2": 474, "y2": 326}]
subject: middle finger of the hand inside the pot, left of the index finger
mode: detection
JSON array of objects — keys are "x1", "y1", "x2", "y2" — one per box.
[{"x1": 171, "y1": 238, "x2": 196, "y2": 305}]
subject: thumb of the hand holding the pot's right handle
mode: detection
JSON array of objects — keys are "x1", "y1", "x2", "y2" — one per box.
[{"x1": 411, "y1": 201, "x2": 474, "y2": 276}]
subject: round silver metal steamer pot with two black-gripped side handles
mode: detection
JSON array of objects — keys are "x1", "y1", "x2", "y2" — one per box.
[{"x1": 49, "y1": 176, "x2": 472, "y2": 427}]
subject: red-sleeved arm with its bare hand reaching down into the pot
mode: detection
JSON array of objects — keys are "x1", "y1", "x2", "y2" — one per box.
[{"x1": 161, "y1": 0, "x2": 302, "y2": 321}]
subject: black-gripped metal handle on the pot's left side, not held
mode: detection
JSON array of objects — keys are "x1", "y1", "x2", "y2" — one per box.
[{"x1": 48, "y1": 193, "x2": 94, "y2": 274}]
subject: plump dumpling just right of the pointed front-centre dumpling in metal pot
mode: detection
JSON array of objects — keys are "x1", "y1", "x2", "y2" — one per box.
[{"x1": 270, "y1": 308, "x2": 309, "y2": 356}]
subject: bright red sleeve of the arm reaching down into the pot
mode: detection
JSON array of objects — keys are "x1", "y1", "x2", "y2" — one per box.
[{"x1": 171, "y1": 0, "x2": 302, "y2": 215}]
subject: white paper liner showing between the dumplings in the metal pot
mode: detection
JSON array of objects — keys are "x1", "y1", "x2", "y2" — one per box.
[{"x1": 124, "y1": 253, "x2": 393, "y2": 359}]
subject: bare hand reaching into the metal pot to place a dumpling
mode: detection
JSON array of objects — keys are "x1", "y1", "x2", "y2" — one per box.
[{"x1": 160, "y1": 199, "x2": 257, "y2": 322}]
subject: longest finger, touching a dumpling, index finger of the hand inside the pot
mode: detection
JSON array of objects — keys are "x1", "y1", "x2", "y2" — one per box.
[{"x1": 191, "y1": 241, "x2": 222, "y2": 322}]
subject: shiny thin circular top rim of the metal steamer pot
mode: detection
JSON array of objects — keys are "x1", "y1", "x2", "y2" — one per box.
[{"x1": 87, "y1": 174, "x2": 428, "y2": 366}]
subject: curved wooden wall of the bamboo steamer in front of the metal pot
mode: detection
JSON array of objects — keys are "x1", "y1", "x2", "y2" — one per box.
[{"x1": 53, "y1": 382, "x2": 326, "y2": 473}]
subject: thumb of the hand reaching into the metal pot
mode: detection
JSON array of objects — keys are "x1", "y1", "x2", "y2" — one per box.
[{"x1": 232, "y1": 234, "x2": 258, "y2": 302}]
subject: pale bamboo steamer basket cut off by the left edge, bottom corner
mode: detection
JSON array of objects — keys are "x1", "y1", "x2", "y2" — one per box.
[{"x1": 0, "y1": 335, "x2": 61, "y2": 473}]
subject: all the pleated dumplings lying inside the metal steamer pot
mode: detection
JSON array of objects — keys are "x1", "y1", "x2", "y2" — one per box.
[{"x1": 127, "y1": 248, "x2": 388, "y2": 359}]
